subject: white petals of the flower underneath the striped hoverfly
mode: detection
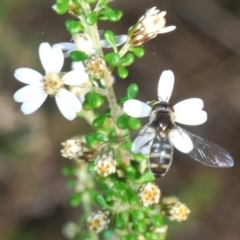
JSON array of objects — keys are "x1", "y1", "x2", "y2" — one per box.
[{"x1": 123, "y1": 71, "x2": 207, "y2": 154}]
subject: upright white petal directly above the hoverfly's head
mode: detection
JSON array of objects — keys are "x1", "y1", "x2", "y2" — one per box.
[{"x1": 158, "y1": 70, "x2": 174, "y2": 102}]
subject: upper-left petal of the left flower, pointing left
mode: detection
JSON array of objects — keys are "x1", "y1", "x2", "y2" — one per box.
[{"x1": 14, "y1": 68, "x2": 43, "y2": 84}]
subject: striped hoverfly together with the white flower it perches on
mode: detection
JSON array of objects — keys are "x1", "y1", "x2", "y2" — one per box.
[{"x1": 123, "y1": 71, "x2": 234, "y2": 177}]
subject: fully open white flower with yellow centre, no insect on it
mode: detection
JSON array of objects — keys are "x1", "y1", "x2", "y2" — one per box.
[{"x1": 13, "y1": 43, "x2": 88, "y2": 120}]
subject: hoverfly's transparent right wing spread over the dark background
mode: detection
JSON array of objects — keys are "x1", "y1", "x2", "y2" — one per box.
[{"x1": 178, "y1": 127, "x2": 234, "y2": 168}]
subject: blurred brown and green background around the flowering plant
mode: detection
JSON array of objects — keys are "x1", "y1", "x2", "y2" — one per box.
[{"x1": 0, "y1": 0, "x2": 240, "y2": 240}]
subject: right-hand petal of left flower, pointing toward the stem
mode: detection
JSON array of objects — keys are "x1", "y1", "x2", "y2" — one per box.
[{"x1": 63, "y1": 70, "x2": 88, "y2": 85}]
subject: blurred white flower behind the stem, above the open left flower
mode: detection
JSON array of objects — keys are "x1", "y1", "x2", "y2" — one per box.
[{"x1": 53, "y1": 33, "x2": 127, "y2": 58}]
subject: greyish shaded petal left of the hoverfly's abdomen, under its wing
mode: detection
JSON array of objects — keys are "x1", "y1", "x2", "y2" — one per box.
[{"x1": 131, "y1": 128, "x2": 155, "y2": 154}]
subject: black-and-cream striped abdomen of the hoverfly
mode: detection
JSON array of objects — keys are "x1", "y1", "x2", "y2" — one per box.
[{"x1": 149, "y1": 135, "x2": 173, "y2": 177}]
